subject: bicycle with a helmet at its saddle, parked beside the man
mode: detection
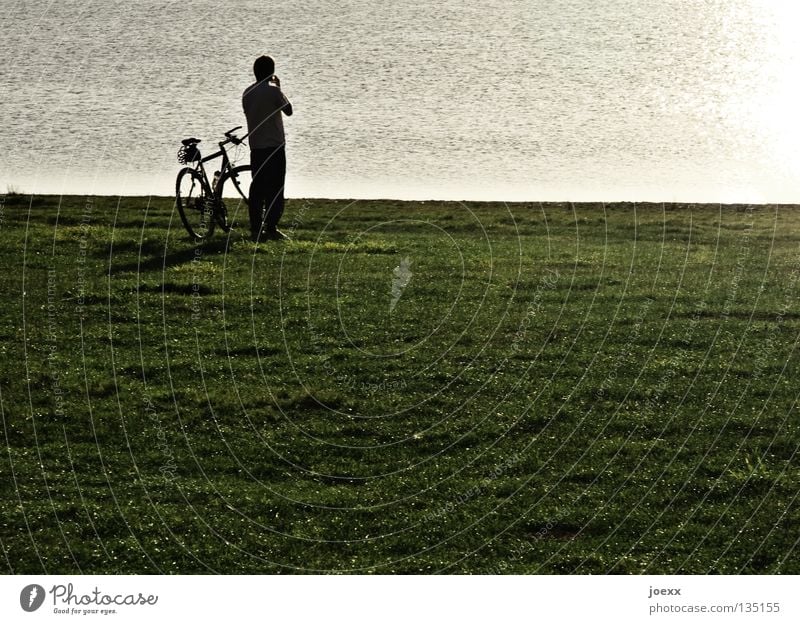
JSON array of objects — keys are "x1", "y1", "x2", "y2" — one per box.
[{"x1": 175, "y1": 126, "x2": 252, "y2": 241}]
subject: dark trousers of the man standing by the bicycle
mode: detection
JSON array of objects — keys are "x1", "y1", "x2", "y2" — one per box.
[{"x1": 249, "y1": 145, "x2": 286, "y2": 233}]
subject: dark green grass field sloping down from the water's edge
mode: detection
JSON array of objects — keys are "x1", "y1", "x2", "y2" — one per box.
[{"x1": 0, "y1": 196, "x2": 800, "y2": 574}]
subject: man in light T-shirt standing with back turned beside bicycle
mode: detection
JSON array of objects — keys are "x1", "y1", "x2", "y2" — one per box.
[{"x1": 242, "y1": 56, "x2": 292, "y2": 241}]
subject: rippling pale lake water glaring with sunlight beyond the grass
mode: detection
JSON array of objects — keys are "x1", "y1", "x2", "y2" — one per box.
[{"x1": 0, "y1": 0, "x2": 800, "y2": 202}]
